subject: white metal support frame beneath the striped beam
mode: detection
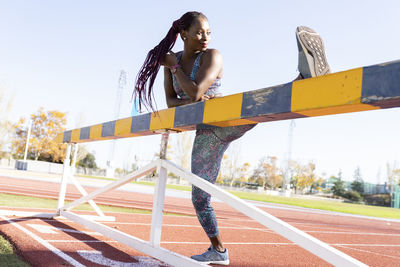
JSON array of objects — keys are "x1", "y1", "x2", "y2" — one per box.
[{"x1": 54, "y1": 145, "x2": 367, "y2": 266}]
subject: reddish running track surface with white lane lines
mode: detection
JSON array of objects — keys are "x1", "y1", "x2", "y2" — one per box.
[{"x1": 0, "y1": 177, "x2": 400, "y2": 266}]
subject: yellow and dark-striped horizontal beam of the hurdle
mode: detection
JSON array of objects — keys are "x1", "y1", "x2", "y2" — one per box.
[{"x1": 57, "y1": 60, "x2": 400, "y2": 143}]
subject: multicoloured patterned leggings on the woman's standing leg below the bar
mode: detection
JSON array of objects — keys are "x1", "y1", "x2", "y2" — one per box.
[{"x1": 192, "y1": 124, "x2": 255, "y2": 237}]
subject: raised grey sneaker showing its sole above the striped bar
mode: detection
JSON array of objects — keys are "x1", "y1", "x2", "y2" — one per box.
[{"x1": 296, "y1": 26, "x2": 331, "y2": 78}]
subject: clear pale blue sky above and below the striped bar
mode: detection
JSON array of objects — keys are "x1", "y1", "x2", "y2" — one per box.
[{"x1": 0, "y1": 0, "x2": 400, "y2": 182}]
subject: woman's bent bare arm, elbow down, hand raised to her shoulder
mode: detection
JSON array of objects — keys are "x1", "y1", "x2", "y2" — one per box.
[{"x1": 167, "y1": 49, "x2": 223, "y2": 101}]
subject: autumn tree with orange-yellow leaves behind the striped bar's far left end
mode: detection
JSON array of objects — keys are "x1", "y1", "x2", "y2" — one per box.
[{"x1": 11, "y1": 108, "x2": 66, "y2": 162}]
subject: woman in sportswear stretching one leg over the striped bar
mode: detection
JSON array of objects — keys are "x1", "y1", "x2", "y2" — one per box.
[{"x1": 135, "y1": 12, "x2": 329, "y2": 265}]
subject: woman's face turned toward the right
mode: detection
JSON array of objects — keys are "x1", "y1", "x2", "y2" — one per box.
[{"x1": 182, "y1": 18, "x2": 211, "y2": 51}]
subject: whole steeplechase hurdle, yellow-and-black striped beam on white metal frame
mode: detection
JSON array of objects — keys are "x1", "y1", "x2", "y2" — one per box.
[{"x1": 43, "y1": 61, "x2": 400, "y2": 266}]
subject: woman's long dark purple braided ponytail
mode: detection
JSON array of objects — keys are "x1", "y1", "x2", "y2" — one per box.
[{"x1": 133, "y1": 11, "x2": 207, "y2": 111}]
